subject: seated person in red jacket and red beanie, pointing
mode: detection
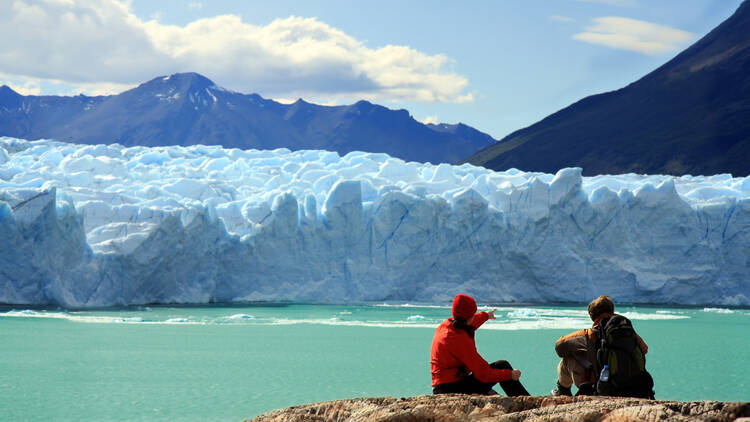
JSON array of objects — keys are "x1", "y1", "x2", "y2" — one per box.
[{"x1": 430, "y1": 294, "x2": 529, "y2": 396}]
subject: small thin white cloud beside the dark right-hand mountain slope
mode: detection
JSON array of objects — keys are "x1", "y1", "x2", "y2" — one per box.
[{"x1": 573, "y1": 16, "x2": 695, "y2": 56}]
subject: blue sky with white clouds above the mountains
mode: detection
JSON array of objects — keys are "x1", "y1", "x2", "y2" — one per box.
[{"x1": 0, "y1": 0, "x2": 742, "y2": 139}]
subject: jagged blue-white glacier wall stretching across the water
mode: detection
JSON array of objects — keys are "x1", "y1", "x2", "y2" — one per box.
[{"x1": 0, "y1": 137, "x2": 750, "y2": 308}]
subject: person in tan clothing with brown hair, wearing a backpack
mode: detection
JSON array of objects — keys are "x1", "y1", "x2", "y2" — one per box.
[{"x1": 551, "y1": 296, "x2": 648, "y2": 396}]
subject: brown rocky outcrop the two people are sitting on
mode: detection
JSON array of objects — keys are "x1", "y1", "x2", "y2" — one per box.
[{"x1": 252, "y1": 395, "x2": 750, "y2": 422}]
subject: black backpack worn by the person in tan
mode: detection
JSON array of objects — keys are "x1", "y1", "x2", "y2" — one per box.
[{"x1": 595, "y1": 315, "x2": 654, "y2": 399}]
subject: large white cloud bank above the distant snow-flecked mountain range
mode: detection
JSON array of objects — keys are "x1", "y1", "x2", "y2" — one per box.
[{"x1": 0, "y1": 0, "x2": 474, "y2": 102}]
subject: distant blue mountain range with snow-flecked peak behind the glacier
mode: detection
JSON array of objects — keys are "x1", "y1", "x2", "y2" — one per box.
[{"x1": 0, "y1": 73, "x2": 495, "y2": 163}]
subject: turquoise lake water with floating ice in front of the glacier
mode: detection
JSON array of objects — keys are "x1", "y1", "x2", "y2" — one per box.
[{"x1": 0, "y1": 305, "x2": 750, "y2": 421}]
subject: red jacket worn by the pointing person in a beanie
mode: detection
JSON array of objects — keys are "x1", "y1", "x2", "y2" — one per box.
[{"x1": 430, "y1": 312, "x2": 511, "y2": 387}]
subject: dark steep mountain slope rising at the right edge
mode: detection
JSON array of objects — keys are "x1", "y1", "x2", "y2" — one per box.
[{"x1": 464, "y1": 0, "x2": 750, "y2": 176}]
